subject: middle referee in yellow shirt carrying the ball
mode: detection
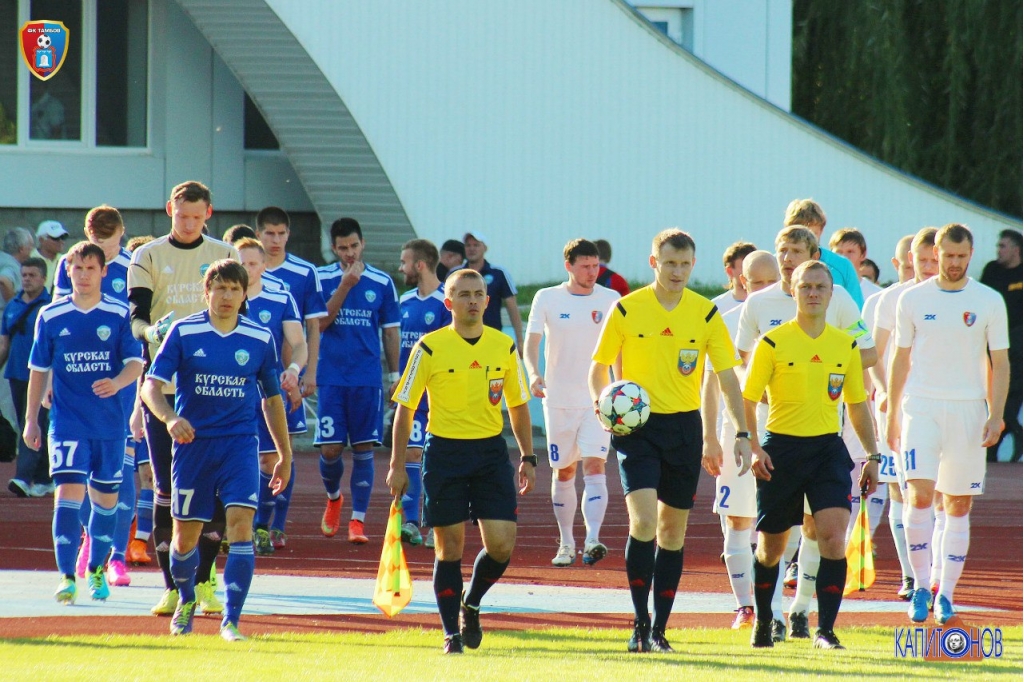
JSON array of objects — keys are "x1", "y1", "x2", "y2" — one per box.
[{"x1": 589, "y1": 228, "x2": 751, "y2": 652}]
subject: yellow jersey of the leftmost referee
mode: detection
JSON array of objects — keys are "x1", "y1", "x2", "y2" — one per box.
[{"x1": 391, "y1": 327, "x2": 529, "y2": 438}]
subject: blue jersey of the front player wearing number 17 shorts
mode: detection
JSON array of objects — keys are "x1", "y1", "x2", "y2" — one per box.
[{"x1": 148, "y1": 310, "x2": 281, "y2": 438}]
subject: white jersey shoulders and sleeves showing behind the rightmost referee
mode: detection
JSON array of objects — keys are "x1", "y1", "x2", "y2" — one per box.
[{"x1": 736, "y1": 282, "x2": 874, "y2": 352}]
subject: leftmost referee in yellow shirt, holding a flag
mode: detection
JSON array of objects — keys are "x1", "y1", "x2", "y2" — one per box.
[{"x1": 387, "y1": 268, "x2": 537, "y2": 653}]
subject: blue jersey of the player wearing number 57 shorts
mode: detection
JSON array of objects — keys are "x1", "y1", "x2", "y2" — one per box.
[{"x1": 29, "y1": 296, "x2": 142, "y2": 440}]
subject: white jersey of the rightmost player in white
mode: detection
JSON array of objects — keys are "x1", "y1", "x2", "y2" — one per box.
[{"x1": 896, "y1": 278, "x2": 1010, "y2": 400}]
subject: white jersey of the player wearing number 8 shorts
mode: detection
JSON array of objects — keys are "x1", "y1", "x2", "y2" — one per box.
[{"x1": 526, "y1": 282, "x2": 618, "y2": 408}]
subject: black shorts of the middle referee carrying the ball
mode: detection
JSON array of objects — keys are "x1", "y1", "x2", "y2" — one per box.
[{"x1": 611, "y1": 410, "x2": 703, "y2": 509}]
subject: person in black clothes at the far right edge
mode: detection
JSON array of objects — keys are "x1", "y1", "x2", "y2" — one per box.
[{"x1": 981, "y1": 229, "x2": 1024, "y2": 462}]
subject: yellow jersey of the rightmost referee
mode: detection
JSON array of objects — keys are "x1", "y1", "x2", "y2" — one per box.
[{"x1": 743, "y1": 319, "x2": 867, "y2": 436}]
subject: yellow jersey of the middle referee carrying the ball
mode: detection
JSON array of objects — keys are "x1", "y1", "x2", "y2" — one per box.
[{"x1": 593, "y1": 286, "x2": 739, "y2": 414}]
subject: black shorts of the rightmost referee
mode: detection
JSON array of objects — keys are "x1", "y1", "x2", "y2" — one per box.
[{"x1": 755, "y1": 433, "x2": 853, "y2": 534}]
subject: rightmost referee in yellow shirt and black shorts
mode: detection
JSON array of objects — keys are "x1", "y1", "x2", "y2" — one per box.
[{"x1": 743, "y1": 260, "x2": 881, "y2": 649}]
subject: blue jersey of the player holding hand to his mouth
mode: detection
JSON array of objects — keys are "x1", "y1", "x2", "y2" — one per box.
[{"x1": 316, "y1": 263, "x2": 400, "y2": 388}]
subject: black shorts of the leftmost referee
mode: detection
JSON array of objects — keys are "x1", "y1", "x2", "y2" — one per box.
[{"x1": 423, "y1": 433, "x2": 519, "y2": 526}]
